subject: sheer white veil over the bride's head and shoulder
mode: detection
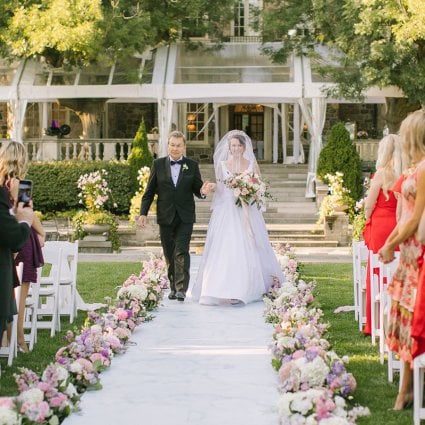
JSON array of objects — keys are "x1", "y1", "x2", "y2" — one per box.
[{"x1": 211, "y1": 130, "x2": 257, "y2": 209}]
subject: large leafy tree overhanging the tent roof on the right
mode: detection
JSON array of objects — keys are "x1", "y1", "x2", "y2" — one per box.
[{"x1": 262, "y1": 0, "x2": 425, "y2": 131}]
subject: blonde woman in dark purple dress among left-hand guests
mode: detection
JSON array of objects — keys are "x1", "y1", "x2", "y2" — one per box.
[{"x1": 0, "y1": 141, "x2": 46, "y2": 352}]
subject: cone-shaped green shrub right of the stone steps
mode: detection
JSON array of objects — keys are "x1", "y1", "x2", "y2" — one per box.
[{"x1": 317, "y1": 123, "x2": 363, "y2": 201}]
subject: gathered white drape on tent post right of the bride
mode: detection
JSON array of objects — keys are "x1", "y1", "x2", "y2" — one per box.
[{"x1": 298, "y1": 97, "x2": 326, "y2": 198}]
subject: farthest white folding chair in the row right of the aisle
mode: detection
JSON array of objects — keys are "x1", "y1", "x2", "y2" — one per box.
[{"x1": 353, "y1": 241, "x2": 369, "y2": 331}]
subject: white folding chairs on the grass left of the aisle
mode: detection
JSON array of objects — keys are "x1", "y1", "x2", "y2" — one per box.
[{"x1": 0, "y1": 241, "x2": 78, "y2": 366}]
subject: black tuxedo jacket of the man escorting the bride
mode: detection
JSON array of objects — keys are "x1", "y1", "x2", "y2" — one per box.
[{"x1": 140, "y1": 156, "x2": 203, "y2": 225}]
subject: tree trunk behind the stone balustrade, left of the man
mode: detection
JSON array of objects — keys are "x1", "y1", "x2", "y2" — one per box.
[{"x1": 60, "y1": 99, "x2": 105, "y2": 139}]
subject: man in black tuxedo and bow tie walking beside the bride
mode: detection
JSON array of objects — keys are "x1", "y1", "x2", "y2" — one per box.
[{"x1": 137, "y1": 131, "x2": 213, "y2": 301}]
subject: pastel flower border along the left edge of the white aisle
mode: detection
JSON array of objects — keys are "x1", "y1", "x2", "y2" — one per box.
[{"x1": 0, "y1": 253, "x2": 168, "y2": 425}]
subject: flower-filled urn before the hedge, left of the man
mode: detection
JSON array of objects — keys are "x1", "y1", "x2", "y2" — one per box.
[{"x1": 72, "y1": 170, "x2": 120, "y2": 251}]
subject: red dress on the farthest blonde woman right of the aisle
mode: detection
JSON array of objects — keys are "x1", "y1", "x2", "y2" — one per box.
[{"x1": 363, "y1": 189, "x2": 397, "y2": 335}]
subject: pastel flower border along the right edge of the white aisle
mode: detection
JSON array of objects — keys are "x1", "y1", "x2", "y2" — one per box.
[{"x1": 270, "y1": 244, "x2": 370, "y2": 425}]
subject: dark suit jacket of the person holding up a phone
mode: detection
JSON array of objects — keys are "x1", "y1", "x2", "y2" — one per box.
[{"x1": 0, "y1": 186, "x2": 30, "y2": 317}]
